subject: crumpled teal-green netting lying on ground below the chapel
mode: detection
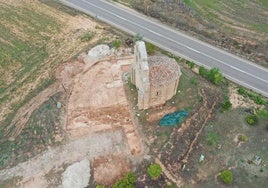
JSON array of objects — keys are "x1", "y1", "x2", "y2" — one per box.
[{"x1": 159, "y1": 110, "x2": 188, "y2": 126}]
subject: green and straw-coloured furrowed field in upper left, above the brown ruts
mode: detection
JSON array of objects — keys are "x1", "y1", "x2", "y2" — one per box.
[{"x1": 0, "y1": 0, "x2": 101, "y2": 139}]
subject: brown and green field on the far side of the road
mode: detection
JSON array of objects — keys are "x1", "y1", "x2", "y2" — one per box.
[{"x1": 116, "y1": 0, "x2": 268, "y2": 67}]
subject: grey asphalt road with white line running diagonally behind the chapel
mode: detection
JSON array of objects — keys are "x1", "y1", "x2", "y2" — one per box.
[{"x1": 61, "y1": 0, "x2": 268, "y2": 96}]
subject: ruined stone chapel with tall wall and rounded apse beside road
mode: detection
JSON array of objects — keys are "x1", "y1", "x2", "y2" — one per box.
[{"x1": 131, "y1": 41, "x2": 181, "y2": 109}]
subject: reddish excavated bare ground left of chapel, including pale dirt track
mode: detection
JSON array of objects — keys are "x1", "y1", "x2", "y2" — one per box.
[{"x1": 0, "y1": 46, "x2": 147, "y2": 187}]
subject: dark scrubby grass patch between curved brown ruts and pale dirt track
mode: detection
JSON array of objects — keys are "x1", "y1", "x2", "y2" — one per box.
[{"x1": 0, "y1": 93, "x2": 65, "y2": 169}]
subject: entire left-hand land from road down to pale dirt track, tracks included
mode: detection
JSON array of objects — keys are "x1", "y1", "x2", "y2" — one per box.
[{"x1": 0, "y1": 0, "x2": 119, "y2": 169}]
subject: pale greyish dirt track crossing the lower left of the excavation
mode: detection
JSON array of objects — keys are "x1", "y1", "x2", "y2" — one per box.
[{"x1": 0, "y1": 130, "x2": 127, "y2": 188}]
